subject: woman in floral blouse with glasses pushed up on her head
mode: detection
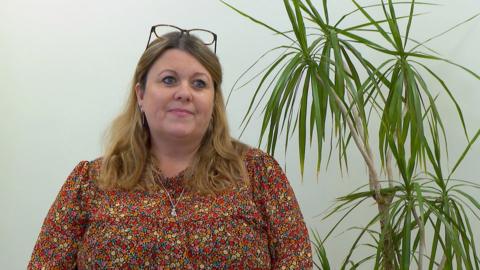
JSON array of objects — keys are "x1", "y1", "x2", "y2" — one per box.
[{"x1": 28, "y1": 25, "x2": 312, "y2": 269}]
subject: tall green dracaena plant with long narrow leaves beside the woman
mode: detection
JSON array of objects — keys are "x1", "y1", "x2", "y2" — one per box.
[{"x1": 223, "y1": 0, "x2": 480, "y2": 269}]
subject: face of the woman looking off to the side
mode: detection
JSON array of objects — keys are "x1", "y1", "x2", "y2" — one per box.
[{"x1": 135, "y1": 49, "x2": 214, "y2": 146}]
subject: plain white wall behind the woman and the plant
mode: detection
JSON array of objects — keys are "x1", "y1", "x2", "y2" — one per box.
[{"x1": 0, "y1": 0, "x2": 480, "y2": 269}]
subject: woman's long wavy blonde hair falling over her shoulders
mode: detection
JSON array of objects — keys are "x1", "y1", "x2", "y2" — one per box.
[{"x1": 98, "y1": 32, "x2": 247, "y2": 194}]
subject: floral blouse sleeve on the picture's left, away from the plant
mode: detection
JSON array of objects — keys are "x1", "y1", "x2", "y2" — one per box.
[{"x1": 28, "y1": 161, "x2": 88, "y2": 269}]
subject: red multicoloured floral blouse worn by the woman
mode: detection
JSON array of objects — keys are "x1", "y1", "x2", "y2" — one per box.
[{"x1": 28, "y1": 149, "x2": 312, "y2": 269}]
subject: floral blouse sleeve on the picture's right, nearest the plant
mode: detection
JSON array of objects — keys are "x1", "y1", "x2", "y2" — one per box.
[{"x1": 249, "y1": 150, "x2": 313, "y2": 269}]
